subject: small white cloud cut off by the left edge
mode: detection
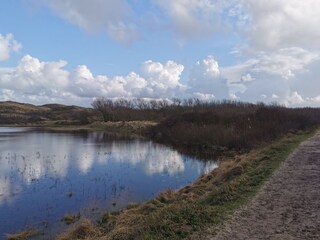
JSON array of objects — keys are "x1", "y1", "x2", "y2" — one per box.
[{"x1": 0, "y1": 33, "x2": 22, "y2": 61}]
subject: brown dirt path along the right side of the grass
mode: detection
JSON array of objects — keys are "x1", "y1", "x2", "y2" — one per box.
[{"x1": 200, "y1": 133, "x2": 320, "y2": 240}]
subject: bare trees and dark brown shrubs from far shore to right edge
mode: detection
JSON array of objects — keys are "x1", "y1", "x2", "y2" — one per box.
[{"x1": 92, "y1": 98, "x2": 320, "y2": 158}]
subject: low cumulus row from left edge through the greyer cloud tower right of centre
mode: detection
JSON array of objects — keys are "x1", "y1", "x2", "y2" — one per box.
[{"x1": 0, "y1": 55, "x2": 235, "y2": 105}]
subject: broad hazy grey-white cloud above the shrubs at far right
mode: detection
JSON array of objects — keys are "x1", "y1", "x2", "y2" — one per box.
[{"x1": 220, "y1": 47, "x2": 320, "y2": 106}]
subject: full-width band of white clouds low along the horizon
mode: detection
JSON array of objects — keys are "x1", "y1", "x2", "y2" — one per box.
[{"x1": 0, "y1": 52, "x2": 320, "y2": 106}]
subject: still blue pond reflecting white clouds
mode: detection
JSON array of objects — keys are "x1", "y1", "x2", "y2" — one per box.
[{"x1": 0, "y1": 127, "x2": 216, "y2": 239}]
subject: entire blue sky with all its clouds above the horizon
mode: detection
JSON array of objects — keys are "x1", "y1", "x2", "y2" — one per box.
[{"x1": 0, "y1": 0, "x2": 320, "y2": 107}]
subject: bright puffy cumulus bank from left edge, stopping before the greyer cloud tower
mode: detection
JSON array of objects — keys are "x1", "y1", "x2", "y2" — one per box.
[{"x1": 0, "y1": 55, "x2": 186, "y2": 105}]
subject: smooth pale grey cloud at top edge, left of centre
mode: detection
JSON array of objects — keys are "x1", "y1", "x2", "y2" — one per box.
[{"x1": 35, "y1": 0, "x2": 139, "y2": 44}]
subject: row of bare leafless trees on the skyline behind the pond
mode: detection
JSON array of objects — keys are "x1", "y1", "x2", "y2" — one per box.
[{"x1": 91, "y1": 97, "x2": 253, "y2": 122}]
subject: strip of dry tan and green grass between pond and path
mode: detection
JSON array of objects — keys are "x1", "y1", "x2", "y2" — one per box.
[{"x1": 59, "y1": 128, "x2": 315, "y2": 239}]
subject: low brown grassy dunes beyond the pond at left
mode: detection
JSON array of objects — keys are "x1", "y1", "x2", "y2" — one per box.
[{"x1": 0, "y1": 101, "x2": 94, "y2": 125}]
